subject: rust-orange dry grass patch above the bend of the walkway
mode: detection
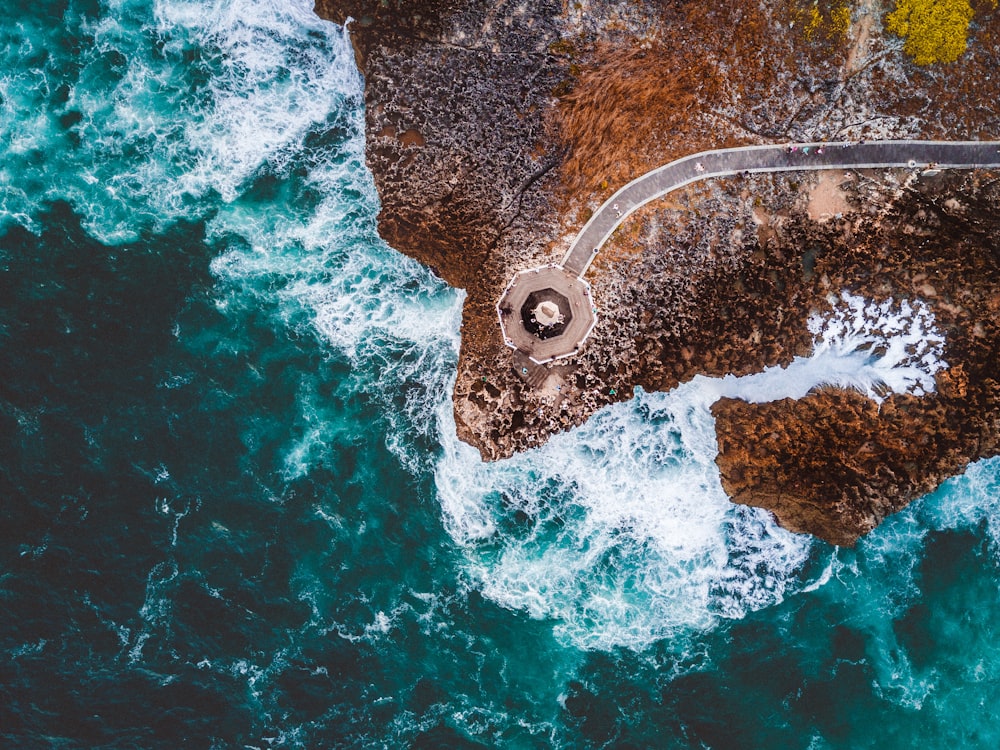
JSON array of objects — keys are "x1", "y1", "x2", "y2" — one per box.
[{"x1": 554, "y1": 0, "x2": 846, "y2": 197}]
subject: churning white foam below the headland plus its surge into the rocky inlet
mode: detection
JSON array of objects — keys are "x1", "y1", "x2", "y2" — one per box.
[{"x1": 436, "y1": 293, "x2": 945, "y2": 649}]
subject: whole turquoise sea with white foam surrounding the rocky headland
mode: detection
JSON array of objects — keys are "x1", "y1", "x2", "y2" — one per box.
[{"x1": 0, "y1": 0, "x2": 1000, "y2": 748}]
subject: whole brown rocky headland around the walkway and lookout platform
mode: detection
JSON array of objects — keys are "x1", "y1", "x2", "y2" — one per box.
[{"x1": 316, "y1": 0, "x2": 1000, "y2": 545}]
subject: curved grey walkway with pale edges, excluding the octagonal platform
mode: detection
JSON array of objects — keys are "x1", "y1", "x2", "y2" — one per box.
[{"x1": 560, "y1": 141, "x2": 1000, "y2": 276}]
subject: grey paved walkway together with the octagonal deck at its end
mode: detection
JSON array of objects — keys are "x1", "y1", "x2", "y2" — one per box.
[{"x1": 497, "y1": 141, "x2": 1000, "y2": 365}]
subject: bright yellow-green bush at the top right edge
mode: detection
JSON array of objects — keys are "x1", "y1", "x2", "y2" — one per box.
[{"x1": 885, "y1": 0, "x2": 972, "y2": 65}]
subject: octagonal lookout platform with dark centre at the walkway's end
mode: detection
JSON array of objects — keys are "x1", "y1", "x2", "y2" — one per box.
[{"x1": 497, "y1": 265, "x2": 597, "y2": 365}]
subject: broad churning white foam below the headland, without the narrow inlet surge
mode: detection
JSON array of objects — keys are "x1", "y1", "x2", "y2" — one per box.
[{"x1": 436, "y1": 384, "x2": 811, "y2": 649}]
